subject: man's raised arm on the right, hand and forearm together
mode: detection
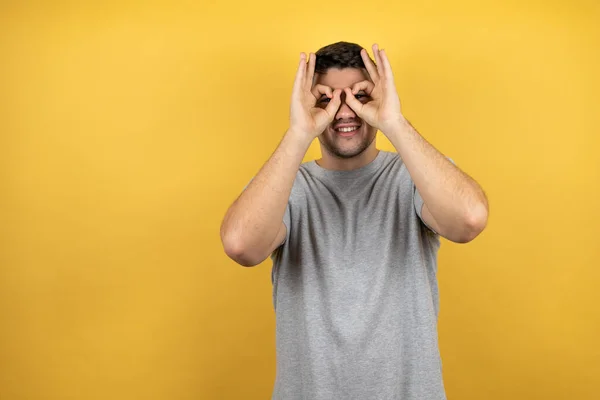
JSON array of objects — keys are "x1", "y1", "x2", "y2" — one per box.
[{"x1": 345, "y1": 45, "x2": 488, "y2": 243}]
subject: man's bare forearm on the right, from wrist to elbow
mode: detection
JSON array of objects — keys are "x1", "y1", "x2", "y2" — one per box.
[{"x1": 387, "y1": 120, "x2": 488, "y2": 237}]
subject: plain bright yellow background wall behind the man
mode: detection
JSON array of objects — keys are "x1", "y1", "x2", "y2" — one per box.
[{"x1": 0, "y1": 0, "x2": 600, "y2": 400}]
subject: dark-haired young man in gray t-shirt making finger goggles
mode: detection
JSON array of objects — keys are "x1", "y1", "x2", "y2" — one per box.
[{"x1": 221, "y1": 42, "x2": 488, "y2": 400}]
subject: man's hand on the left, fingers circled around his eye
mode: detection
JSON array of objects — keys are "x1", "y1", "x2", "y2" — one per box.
[{"x1": 289, "y1": 53, "x2": 342, "y2": 141}]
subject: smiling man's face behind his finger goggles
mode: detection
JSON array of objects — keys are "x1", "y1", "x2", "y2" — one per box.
[{"x1": 315, "y1": 68, "x2": 377, "y2": 158}]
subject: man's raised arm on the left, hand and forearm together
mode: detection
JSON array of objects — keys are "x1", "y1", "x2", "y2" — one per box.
[{"x1": 220, "y1": 53, "x2": 341, "y2": 267}]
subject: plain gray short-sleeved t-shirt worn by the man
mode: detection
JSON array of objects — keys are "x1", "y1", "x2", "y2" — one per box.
[{"x1": 271, "y1": 150, "x2": 446, "y2": 400}]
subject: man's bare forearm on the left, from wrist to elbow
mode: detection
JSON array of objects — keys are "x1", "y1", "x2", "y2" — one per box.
[{"x1": 221, "y1": 131, "x2": 310, "y2": 264}]
